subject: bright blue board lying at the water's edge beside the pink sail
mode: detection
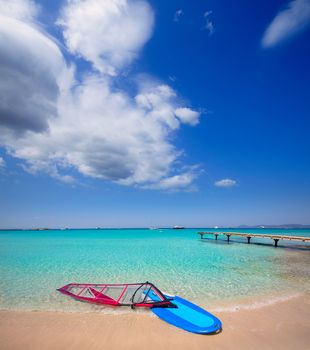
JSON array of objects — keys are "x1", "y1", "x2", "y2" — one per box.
[{"x1": 148, "y1": 293, "x2": 222, "y2": 334}]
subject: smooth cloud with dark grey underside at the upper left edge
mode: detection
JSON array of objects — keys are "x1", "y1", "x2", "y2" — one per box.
[{"x1": 0, "y1": 1, "x2": 66, "y2": 132}]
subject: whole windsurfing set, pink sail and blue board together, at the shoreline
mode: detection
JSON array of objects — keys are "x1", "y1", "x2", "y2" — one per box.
[{"x1": 58, "y1": 282, "x2": 222, "y2": 334}]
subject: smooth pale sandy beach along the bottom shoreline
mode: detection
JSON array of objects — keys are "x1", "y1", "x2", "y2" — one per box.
[{"x1": 0, "y1": 294, "x2": 310, "y2": 350}]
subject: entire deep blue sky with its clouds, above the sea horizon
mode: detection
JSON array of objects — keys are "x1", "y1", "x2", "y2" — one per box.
[{"x1": 0, "y1": 0, "x2": 310, "y2": 228}]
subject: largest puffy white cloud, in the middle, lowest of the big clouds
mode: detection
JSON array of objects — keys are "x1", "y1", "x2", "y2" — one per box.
[{"x1": 7, "y1": 75, "x2": 201, "y2": 189}]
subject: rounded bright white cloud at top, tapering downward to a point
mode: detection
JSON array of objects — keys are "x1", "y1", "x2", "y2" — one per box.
[{"x1": 59, "y1": 0, "x2": 154, "y2": 76}]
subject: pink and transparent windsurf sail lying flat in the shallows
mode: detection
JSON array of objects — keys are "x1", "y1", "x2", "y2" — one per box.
[{"x1": 57, "y1": 282, "x2": 175, "y2": 308}]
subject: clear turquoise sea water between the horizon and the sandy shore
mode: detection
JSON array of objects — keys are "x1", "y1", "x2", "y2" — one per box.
[{"x1": 0, "y1": 229, "x2": 310, "y2": 313}]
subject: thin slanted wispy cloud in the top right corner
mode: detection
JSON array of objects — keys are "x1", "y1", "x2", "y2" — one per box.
[{"x1": 262, "y1": 0, "x2": 310, "y2": 48}]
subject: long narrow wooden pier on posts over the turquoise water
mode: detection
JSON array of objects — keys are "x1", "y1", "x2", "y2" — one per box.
[{"x1": 197, "y1": 232, "x2": 310, "y2": 247}]
